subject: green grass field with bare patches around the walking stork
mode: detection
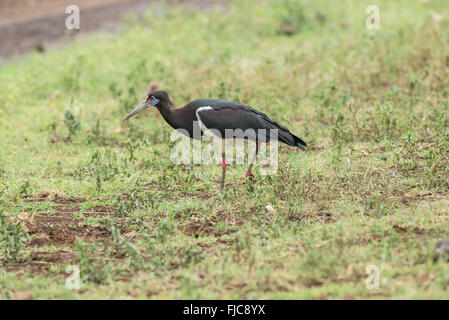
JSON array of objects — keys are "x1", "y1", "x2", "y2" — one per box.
[{"x1": 0, "y1": 0, "x2": 449, "y2": 299}]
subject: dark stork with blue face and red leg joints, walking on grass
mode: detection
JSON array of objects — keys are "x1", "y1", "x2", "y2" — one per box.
[{"x1": 124, "y1": 91, "x2": 307, "y2": 189}]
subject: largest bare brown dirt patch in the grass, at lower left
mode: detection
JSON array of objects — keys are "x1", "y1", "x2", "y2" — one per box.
[{"x1": 5, "y1": 191, "x2": 118, "y2": 275}]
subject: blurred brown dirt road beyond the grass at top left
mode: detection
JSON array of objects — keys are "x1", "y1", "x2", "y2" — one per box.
[{"x1": 0, "y1": 0, "x2": 226, "y2": 58}]
